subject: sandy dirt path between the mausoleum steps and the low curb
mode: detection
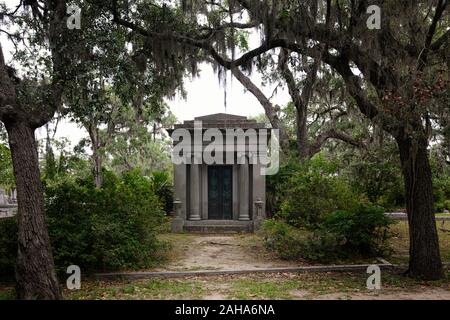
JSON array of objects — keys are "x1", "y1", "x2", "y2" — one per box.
[{"x1": 158, "y1": 234, "x2": 302, "y2": 271}]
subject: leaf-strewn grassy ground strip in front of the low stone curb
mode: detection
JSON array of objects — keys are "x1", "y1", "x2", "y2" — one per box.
[{"x1": 0, "y1": 271, "x2": 450, "y2": 300}]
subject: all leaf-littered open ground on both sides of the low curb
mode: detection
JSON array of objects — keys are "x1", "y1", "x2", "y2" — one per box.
[{"x1": 0, "y1": 221, "x2": 450, "y2": 300}]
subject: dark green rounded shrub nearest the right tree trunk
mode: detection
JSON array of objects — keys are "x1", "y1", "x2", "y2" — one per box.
[{"x1": 323, "y1": 204, "x2": 394, "y2": 256}]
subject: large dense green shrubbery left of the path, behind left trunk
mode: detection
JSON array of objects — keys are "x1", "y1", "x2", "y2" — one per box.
[{"x1": 0, "y1": 171, "x2": 164, "y2": 273}]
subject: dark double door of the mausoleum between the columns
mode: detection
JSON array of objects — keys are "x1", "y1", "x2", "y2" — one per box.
[{"x1": 208, "y1": 166, "x2": 233, "y2": 219}]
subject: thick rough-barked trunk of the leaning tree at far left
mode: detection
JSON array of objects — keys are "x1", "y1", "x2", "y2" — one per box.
[{"x1": 5, "y1": 121, "x2": 62, "y2": 299}]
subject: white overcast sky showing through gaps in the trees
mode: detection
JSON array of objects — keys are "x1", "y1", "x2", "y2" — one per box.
[{"x1": 0, "y1": 0, "x2": 289, "y2": 145}]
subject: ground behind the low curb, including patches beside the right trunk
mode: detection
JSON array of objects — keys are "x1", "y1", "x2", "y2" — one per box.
[{"x1": 153, "y1": 221, "x2": 450, "y2": 271}]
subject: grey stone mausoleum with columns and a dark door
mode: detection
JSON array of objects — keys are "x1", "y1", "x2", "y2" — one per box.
[{"x1": 169, "y1": 113, "x2": 270, "y2": 232}]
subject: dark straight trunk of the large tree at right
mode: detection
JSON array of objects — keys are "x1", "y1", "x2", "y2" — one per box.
[{"x1": 397, "y1": 138, "x2": 443, "y2": 280}]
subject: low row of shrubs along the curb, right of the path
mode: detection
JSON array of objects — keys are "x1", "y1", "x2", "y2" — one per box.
[{"x1": 261, "y1": 205, "x2": 393, "y2": 262}]
